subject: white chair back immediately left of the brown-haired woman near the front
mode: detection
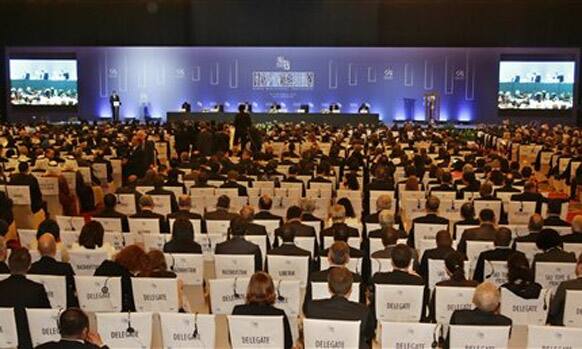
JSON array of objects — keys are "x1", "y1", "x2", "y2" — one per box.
[{"x1": 208, "y1": 277, "x2": 250, "y2": 315}]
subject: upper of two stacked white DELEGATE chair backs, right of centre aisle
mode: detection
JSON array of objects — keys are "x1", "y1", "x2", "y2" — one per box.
[{"x1": 375, "y1": 285, "x2": 424, "y2": 322}]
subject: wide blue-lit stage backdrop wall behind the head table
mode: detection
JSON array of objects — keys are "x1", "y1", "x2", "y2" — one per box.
[{"x1": 5, "y1": 47, "x2": 579, "y2": 123}]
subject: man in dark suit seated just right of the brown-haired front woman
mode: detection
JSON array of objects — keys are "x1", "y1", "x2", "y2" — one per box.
[{"x1": 305, "y1": 268, "x2": 376, "y2": 349}]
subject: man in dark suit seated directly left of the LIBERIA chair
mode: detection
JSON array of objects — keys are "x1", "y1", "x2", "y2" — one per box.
[{"x1": 214, "y1": 216, "x2": 263, "y2": 271}]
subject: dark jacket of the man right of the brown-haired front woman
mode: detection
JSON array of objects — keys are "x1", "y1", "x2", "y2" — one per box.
[{"x1": 304, "y1": 297, "x2": 376, "y2": 349}]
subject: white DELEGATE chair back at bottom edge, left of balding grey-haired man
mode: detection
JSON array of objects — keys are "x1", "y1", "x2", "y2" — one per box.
[{"x1": 382, "y1": 321, "x2": 440, "y2": 349}]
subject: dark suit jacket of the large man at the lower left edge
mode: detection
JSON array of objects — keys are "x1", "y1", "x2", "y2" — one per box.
[{"x1": 0, "y1": 275, "x2": 51, "y2": 349}]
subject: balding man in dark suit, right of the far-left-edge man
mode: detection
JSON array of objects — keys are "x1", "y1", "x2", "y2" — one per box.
[{"x1": 28, "y1": 233, "x2": 78, "y2": 307}]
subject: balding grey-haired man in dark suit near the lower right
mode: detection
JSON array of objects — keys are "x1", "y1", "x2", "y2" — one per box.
[{"x1": 451, "y1": 282, "x2": 512, "y2": 326}]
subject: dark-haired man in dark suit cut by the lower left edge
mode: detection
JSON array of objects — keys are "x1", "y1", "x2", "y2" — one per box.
[{"x1": 0, "y1": 248, "x2": 51, "y2": 349}]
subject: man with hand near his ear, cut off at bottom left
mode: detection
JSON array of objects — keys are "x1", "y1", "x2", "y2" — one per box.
[{"x1": 36, "y1": 308, "x2": 109, "y2": 349}]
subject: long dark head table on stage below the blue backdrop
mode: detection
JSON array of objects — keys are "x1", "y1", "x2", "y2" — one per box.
[{"x1": 167, "y1": 112, "x2": 380, "y2": 126}]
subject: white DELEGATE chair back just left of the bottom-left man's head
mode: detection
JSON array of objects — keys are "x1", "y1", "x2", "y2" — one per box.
[{"x1": 26, "y1": 309, "x2": 61, "y2": 347}]
